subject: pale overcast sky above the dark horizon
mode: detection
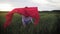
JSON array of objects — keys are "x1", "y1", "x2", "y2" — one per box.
[{"x1": 0, "y1": 0, "x2": 60, "y2": 11}]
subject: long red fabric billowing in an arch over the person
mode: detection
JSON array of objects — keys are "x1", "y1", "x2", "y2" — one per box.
[{"x1": 4, "y1": 7, "x2": 39, "y2": 28}]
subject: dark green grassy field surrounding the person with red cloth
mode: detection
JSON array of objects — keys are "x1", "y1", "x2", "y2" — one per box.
[{"x1": 0, "y1": 12, "x2": 60, "y2": 34}]
